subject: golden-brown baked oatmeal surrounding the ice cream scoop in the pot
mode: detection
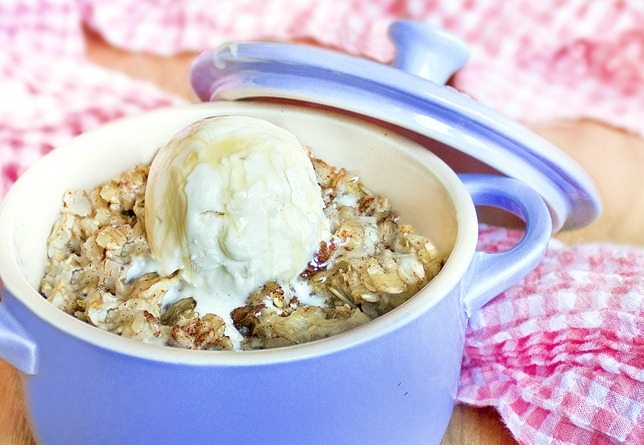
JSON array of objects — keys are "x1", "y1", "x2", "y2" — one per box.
[{"x1": 40, "y1": 155, "x2": 443, "y2": 350}]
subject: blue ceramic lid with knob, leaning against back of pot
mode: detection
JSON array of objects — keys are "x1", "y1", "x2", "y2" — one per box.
[{"x1": 191, "y1": 21, "x2": 601, "y2": 230}]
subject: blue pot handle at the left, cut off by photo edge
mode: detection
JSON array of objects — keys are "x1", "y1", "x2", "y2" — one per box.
[{"x1": 0, "y1": 281, "x2": 37, "y2": 375}]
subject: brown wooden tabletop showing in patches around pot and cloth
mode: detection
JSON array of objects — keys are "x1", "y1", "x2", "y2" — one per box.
[{"x1": 0, "y1": 33, "x2": 644, "y2": 445}]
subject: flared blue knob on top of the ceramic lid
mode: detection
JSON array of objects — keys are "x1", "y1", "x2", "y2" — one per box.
[{"x1": 389, "y1": 20, "x2": 470, "y2": 85}]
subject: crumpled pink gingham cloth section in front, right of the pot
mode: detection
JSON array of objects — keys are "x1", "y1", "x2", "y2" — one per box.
[{"x1": 458, "y1": 227, "x2": 644, "y2": 444}]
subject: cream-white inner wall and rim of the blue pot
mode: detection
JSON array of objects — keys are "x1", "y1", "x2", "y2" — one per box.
[{"x1": 0, "y1": 103, "x2": 477, "y2": 364}]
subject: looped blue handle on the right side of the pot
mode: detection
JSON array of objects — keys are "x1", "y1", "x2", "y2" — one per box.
[{"x1": 459, "y1": 174, "x2": 552, "y2": 317}]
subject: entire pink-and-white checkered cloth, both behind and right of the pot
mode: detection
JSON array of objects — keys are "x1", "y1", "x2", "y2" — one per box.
[{"x1": 0, "y1": 0, "x2": 644, "y2": 444}]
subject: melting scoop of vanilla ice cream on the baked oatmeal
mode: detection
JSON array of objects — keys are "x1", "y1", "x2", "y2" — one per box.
[{"x1": 145, "y1": 116, "x2": 329, "y2": 315}]
